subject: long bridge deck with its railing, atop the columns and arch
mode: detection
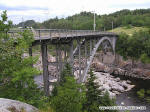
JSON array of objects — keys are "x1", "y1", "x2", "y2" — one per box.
[{"x1": 9, "y1": 29, "x2": 117, "y2": 41}]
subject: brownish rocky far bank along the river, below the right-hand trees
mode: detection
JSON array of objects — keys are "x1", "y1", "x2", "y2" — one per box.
[{"x1": 91, "y1": 61, "x2": 150, "y2": 79}]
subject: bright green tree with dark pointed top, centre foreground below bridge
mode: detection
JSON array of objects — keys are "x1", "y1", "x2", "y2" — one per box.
[{"x1": 51, "y1": 63, "x2": 85, "y2": 112}]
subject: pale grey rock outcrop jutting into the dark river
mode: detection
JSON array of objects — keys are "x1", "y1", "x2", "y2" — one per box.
[{"x1": 94, "y1": 72, "x2": 134, "y2": 98}]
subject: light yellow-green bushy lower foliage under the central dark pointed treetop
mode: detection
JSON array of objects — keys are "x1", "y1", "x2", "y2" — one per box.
[{"x1": 51, "y1": 76, "x2": 84, "y2": 112}]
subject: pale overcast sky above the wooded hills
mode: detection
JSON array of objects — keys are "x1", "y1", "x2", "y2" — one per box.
[{"x1": 0, "y1": 0, "x2": 150, "y2": 24}]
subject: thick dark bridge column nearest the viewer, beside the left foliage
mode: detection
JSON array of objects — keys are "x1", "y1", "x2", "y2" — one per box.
[{"x1": 41, "y1": 42, "x2": 49, "y2": 96}]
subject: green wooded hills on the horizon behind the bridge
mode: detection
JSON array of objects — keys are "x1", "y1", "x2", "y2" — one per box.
[{"x1": 16, "y1": 9, "x2": 150, "y2": 31}]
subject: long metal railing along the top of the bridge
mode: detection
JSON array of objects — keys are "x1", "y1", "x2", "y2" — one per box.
[{"x1": 8, "y1": 29, "x2": 113, "y2": 39}]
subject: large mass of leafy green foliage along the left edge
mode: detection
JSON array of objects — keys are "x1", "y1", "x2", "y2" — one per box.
[{"x1": 0, "y1": 11, "x2": 46, "y2": 106}]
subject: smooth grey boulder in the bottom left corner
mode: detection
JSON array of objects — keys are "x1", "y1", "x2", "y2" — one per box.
[{"x1": 0, "y1": 98, "x2": 38, "y2": 112}]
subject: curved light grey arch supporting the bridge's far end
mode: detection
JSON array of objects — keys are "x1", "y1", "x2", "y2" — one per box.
[{"x1": 80, "y1": 36, "x2": 116, "y2": 82}]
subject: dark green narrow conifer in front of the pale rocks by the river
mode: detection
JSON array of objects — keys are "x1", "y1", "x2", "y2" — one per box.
[{"x1": 83, "y1": 70, "x2": 116, "y2": 112}]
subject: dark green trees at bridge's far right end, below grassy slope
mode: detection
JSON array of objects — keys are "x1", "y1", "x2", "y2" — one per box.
[{"x1": 116, "y1": 31, "x2": 150, "y2": 63}]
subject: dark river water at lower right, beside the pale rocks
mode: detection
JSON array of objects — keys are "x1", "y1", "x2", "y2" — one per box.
[{"x1": 113, "y1": 76, "x2": 150, "y2": 112}]
